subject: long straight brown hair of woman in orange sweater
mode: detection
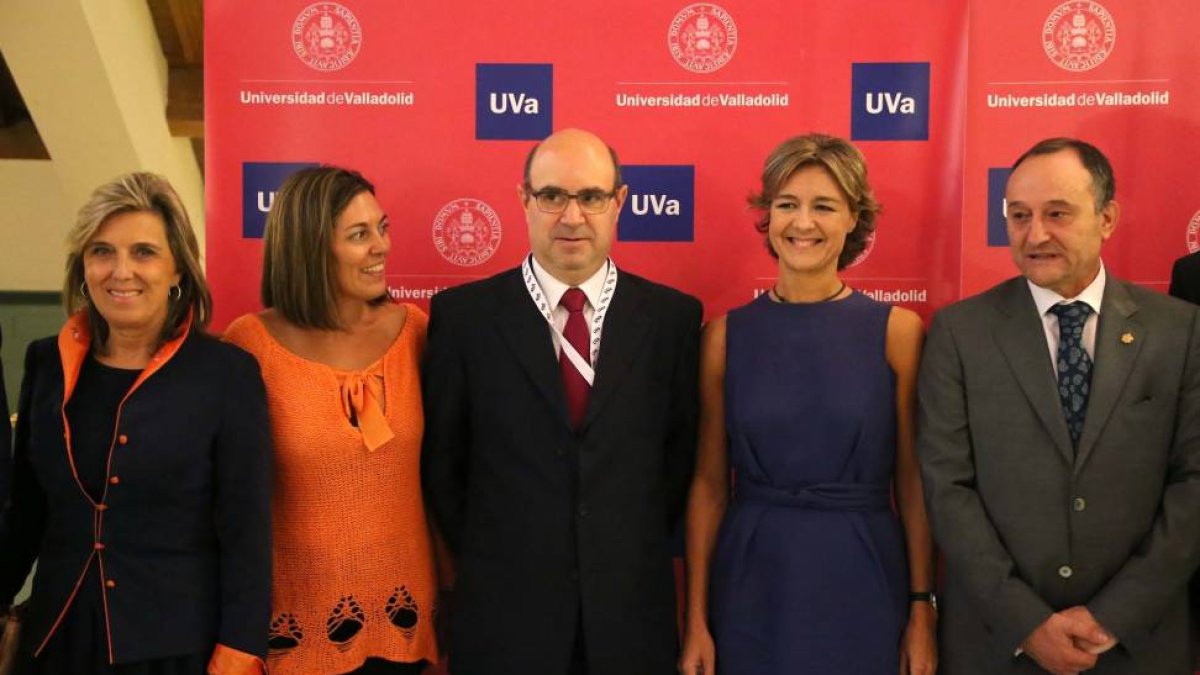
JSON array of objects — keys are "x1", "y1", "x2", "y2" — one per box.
[{"x1": 262, "y1": 166, "x2": 374, "y2": 330}]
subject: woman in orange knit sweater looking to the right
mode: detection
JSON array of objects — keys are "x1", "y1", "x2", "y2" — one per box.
[{"x1": 226, "y1": 167, "x2": 437, "y2": 675}]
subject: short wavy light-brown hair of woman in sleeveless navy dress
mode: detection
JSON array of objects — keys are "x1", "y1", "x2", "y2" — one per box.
[{"x1": 748, "y1": 133, "x2": 880, "y2": 269}]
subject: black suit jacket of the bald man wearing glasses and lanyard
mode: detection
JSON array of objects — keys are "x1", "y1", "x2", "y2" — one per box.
[{"x1": 422, "y1": 269, "x2": 701, "y2": 675}]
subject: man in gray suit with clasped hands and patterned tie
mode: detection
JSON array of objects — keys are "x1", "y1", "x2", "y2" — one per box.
[{"x1": 918, "y1": 138, "x2": 1200, "y2": 675}]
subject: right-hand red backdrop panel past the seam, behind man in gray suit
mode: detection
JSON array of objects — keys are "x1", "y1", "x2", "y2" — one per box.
[{"x1": 961, "y1": 0, "x2": 1200, "y2": 295}]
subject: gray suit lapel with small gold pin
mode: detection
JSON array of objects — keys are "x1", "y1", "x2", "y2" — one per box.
[{"x1": 1075, "y1": 276, "x2": 1147, "y2": 471}]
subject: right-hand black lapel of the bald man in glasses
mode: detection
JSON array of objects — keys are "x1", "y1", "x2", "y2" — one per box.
[{"x1": 578, "y1": 274, "x2": 650, "y2": 430}]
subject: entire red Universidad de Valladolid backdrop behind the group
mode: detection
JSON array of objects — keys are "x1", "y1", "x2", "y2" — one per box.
[{"x1": 205, "y1": 0, "x2": 1200, "y2": 328}]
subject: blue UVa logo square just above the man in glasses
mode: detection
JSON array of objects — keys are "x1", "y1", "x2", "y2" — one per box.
[{"x1": 475, "y1": 64, "x2": 554, "y2": 141}]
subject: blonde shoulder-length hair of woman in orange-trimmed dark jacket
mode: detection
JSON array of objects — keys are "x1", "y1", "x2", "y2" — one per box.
[{"x1": 62, "y1": 172, "x2": 212, "y2": 350}]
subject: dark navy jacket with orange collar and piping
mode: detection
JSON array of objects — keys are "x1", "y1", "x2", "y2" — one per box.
[{"x1": 0, "y1": 316, "x2": 271, "y2": 663}]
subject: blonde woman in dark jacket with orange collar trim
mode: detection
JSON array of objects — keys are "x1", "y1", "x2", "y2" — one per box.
[{"x1": 0, "y1": 173, "x2": 271, "y2": 675}]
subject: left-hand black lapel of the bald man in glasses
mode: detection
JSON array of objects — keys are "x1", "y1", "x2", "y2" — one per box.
[{"x1": 494, "y1": 269, "x2": 568, "y2": 425}]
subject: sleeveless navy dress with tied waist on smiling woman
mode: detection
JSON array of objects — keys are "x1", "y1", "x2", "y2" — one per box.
[{"x1": 709, "y1": 292, "x2": 908, "y2": 675}]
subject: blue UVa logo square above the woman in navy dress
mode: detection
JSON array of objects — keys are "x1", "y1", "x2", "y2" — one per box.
[{"x1": 850, "y1": 62, "x2": 929, "y2": 141}]
